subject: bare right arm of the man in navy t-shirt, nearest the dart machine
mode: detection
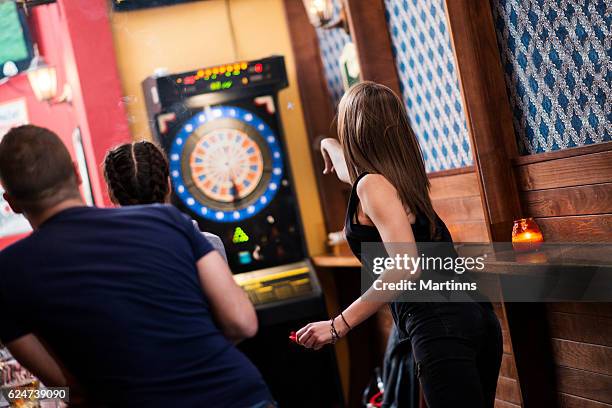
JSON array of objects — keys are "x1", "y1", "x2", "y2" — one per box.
[{"x1": 197, "y1": 251, "x2": 258, "y2": 341}]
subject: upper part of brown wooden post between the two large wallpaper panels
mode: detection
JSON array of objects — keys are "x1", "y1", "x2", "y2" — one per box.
[{"x1": 446, "y1": 0, "x2": 521, "y2": 242}]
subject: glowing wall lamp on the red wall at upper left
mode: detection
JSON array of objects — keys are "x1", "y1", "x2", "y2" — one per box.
[{"x1": 26, "y1": 52, "x2": 72, "y2": 104}]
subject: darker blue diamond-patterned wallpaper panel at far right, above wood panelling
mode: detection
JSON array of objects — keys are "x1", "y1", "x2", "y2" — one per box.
[{"x1": 491, "y1": 0, "x2": 612, "y2": 154}]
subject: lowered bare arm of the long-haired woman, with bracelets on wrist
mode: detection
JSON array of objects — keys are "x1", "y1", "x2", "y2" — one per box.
[{"x1": 297, "y1": 174, "x2": 418, "y2": 350}]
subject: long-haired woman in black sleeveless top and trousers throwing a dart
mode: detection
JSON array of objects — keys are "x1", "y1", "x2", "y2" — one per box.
[{"x1": 297, "y1": 82, "x2": 502, "y2": 408}]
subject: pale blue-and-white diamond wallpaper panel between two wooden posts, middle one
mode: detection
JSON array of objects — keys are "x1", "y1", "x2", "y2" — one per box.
[{"x1": 385, "y1": 0, "x2": 472, "y2": 172}]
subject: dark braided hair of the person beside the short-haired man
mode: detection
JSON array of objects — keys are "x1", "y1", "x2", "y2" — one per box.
[{"x1": 104, "y1": 140, "x2": 169, "y2": 205}]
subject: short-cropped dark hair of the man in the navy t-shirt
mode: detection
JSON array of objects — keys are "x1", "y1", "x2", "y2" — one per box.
[{"x1": 0, "y1": 125, "x2": 80, "y2": 213}]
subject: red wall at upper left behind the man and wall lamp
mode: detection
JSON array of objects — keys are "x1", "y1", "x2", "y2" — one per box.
[{"x1": 0, "y1": 0, "x2": 131, "y2": 248}]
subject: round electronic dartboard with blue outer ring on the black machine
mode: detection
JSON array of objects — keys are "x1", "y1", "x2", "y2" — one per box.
[{"x1": 170, "y1": 106, "x2": 283, "y2": 222}]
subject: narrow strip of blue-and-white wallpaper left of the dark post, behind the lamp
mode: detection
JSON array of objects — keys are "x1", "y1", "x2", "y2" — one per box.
[{"x1": 316, "y1": 0, "x2": 351, "y2": 106}]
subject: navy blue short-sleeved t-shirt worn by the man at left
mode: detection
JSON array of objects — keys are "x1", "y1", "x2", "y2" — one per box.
[{"x1": 0, "y1": 205, "x2": 270, "y2": 408}]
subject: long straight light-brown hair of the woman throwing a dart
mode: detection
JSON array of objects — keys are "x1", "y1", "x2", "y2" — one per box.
[{"x1": 338, "y1": 81, "x2": 436, "y2": 238}]
